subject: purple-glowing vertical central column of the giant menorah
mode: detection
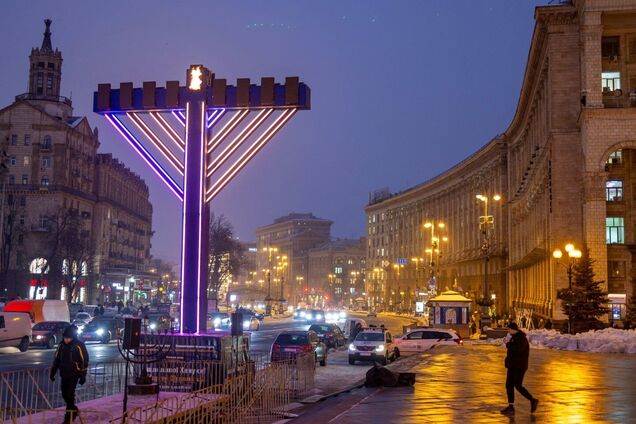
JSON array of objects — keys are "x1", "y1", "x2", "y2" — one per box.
[{"x1": 181, "y1": 97, "x2": 208, "y2": 333}]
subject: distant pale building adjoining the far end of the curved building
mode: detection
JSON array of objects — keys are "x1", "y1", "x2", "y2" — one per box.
[{"x1": 308, "y1": 237, "x2": 368, "y2": 307}]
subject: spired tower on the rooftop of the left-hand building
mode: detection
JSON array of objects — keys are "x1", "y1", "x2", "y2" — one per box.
[{"x1": 23, "y1": 19, "x2": 72, "y2": 118}]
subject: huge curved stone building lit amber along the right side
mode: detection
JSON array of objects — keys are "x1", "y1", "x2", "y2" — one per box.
[{"x1": 366, "y1": 0, "x2": 636, "y2": 320}]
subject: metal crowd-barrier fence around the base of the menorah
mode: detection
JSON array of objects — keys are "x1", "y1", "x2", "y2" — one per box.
[{"x1": 0, "y1": 352, "x2": 316, "y2": 423}]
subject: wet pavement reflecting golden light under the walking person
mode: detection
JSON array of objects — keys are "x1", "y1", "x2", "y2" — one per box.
[{"x1": 293, "y1": 345, "x2": 636, "y2": 424}]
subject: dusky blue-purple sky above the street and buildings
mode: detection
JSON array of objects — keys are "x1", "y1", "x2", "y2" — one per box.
[{"x1": 0, "y1": 0, "x2": 548, "y2": 263}]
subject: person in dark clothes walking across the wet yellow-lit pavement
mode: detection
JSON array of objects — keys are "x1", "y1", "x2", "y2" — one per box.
[{"x1": 501, "y1": 322, "x2": 539, "y2": 414}]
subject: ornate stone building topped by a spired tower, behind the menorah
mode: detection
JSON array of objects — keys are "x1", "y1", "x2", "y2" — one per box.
[{"x1": 0, "y1": 20, "x2": 152, "y2": 303}]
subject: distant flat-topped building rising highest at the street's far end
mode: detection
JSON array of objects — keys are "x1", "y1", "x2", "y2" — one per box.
[{"x1": 256, "y1": 213, "x2": 333, "y2": 303}]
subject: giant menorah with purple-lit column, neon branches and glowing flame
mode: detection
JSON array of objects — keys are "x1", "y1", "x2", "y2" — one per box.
[{"x1": 93, "y1": 65, "x2": 310, "y2": 333}]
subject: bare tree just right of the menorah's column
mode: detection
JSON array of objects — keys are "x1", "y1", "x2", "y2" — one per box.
[{"x1": 208, "y1": 213, "x2": 245, "y2": 305}]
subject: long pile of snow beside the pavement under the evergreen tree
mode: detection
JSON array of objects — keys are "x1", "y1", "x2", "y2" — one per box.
[{"x1": 527, "y1": 328, "x2": 636, "y2": 354}]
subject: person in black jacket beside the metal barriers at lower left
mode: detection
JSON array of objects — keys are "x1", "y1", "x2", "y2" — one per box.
[{"x1": 50, "y1": 325, "x2": 88, "y2": 423}]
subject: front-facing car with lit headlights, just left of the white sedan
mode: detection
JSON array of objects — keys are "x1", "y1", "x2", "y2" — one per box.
[{"x1": 349, "y1": 327, "x2": 399, "y2": 365}]
